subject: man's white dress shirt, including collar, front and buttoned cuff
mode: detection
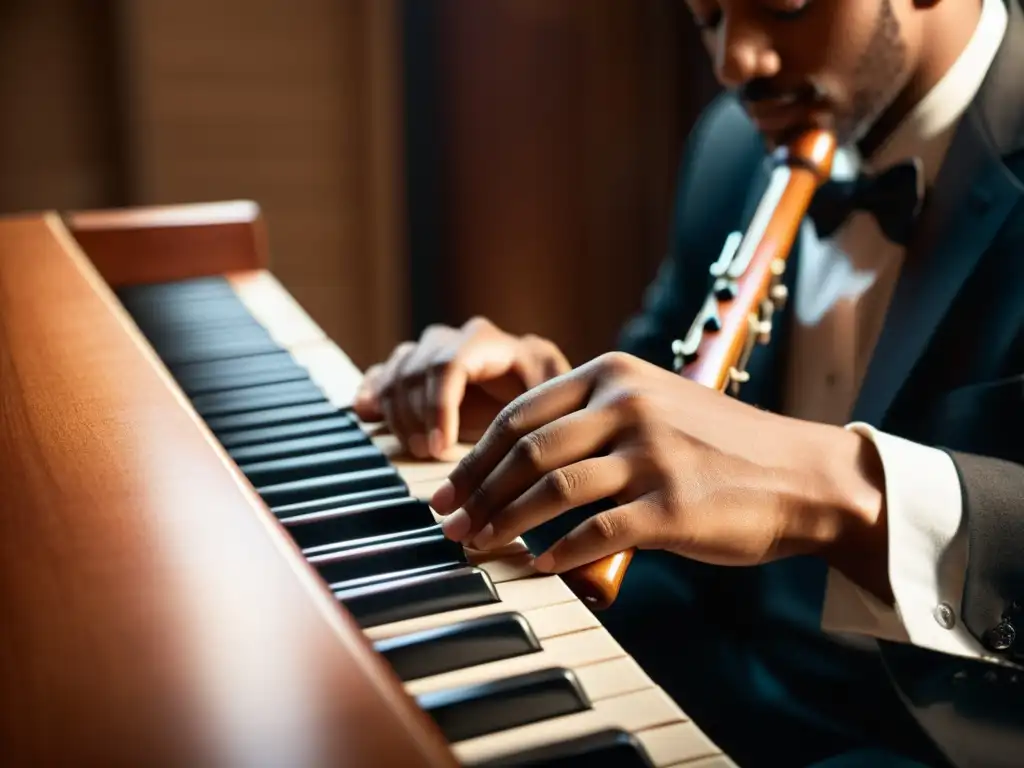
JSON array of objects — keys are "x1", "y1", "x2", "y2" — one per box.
[{"x1": 784, "y1": 0, "x2": 1008, "y2": 657}]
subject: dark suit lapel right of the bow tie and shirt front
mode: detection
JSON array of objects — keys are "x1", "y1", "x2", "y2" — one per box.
[{"x1": 853, "y1": 0, "x2": 1024, "y2": 425}]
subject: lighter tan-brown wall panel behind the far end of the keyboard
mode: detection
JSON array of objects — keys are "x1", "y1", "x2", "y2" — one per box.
[{"x1": 122, "y1": 0, "x2": 406, "y2": 365}]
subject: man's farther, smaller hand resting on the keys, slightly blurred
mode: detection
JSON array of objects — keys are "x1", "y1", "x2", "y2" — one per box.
[{"x1": 353, "y1": 317, "x2": 570, "y2": 459}]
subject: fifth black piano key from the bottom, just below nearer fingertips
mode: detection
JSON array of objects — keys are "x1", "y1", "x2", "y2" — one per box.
[{"x1": 307, "y1": 526, "x2": 466, "y2": 585}]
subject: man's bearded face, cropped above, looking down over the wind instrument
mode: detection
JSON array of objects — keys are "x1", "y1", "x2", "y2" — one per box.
[{"x1": 687, "y1": 0, "x2": 921, "y2": 144}]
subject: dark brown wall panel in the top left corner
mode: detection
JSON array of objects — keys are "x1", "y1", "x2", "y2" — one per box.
[{"x1": 0, "y1": 0, "x2": 123, "y2": 212}]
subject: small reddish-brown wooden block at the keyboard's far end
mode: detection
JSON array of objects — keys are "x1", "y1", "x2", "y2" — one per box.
[{"x1": 65, "y1": 201, "x2": 269, "y2": 288}]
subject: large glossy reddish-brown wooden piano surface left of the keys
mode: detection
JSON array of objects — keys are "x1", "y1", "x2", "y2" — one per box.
[{"x1": 0, "y1": 215, "x2": 455, "y2": 768}]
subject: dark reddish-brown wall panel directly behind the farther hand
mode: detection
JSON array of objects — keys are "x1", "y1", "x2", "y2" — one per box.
[{"x1": 428, "y1": 0, "x2": 713, "y2": 362}]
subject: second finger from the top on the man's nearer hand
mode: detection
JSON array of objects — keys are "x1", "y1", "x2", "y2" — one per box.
[{"x1": 444, "y1": 409, "x2": 617, "y2": 541}]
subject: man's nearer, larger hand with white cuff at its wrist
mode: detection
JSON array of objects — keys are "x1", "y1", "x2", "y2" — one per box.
[{"x1": 431, "y1": 352, "x2": 886, "y2": 593}]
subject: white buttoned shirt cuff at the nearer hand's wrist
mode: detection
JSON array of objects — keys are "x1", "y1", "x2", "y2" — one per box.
[{"x1": 822, "y1": 422, "x2": 989, "y2": 657}]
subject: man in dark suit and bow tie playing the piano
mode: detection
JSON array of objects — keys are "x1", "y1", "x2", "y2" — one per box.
[{"x1": 356, "y1": 0, "x2": 1024, "y2": 766}]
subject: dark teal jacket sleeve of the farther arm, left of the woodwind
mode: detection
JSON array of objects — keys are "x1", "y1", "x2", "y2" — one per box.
[{"x1": 618, "y1": 95, "x2": 765, "y2": 368}]
